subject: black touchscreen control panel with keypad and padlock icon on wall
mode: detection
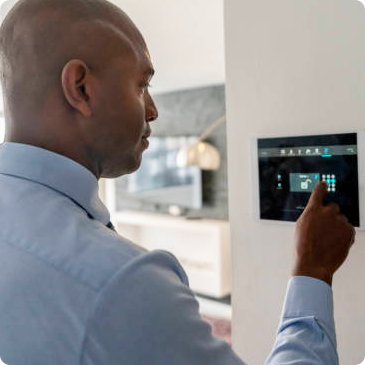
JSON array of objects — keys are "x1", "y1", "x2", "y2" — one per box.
[{"x1": 257, "y1": 133, "x2": 359, "y2": 227}]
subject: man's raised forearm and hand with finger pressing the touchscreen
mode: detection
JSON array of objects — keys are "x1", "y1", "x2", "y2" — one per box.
[{"x1": 266, "y1": 183, "x2": 355, "y2": 365}]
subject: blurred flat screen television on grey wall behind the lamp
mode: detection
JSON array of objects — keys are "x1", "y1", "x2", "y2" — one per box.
[{"x1": 125, "y1": 137, "x2": 203, "y2": 209}]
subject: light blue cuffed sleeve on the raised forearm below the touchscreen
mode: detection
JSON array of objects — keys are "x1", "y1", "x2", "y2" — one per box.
[{"x1": 265, "y1": 276, "x2": 338, "y2": 365}]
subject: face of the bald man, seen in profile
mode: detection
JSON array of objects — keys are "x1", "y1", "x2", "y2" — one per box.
[{"x1": 93, "y1": 41, "x2": 158, "y2": 178}]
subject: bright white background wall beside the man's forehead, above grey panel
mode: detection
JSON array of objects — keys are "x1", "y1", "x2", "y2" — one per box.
[{"x1": 111, "y1": 0, "x2": 225, "y2": 93}]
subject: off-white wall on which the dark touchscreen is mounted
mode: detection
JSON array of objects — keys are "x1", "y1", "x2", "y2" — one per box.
[{"x1": 225, "y1": 0, "x2": 365, "y2": 365}]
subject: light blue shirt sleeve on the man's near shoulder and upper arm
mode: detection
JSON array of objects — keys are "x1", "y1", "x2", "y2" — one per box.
[{"x1": 80, "y1": 251, "x2": 244, "y2": 365}]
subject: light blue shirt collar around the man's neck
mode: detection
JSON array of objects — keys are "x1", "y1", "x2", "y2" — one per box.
[{"x1": 0, "y1": 142, "x2": 110, "y2": 225}]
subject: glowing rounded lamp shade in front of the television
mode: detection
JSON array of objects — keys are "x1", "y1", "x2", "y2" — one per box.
[{"x1": 176, "y1": 142, "x2": 221, "y2": 170}]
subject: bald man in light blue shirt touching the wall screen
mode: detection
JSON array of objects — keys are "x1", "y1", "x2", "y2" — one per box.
[{"x1": 0, "y1": 0, "x2": 354, "y2": 365}]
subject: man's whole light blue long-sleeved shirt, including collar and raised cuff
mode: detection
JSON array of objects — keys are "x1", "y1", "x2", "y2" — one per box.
[{"x1": 0, "y1": 143, "x2": 337, "y2": 365}]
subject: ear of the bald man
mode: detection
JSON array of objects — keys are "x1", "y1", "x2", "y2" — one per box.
[{"x1": 62, "y1": 60, "x2": 92, "y2": 117}]
